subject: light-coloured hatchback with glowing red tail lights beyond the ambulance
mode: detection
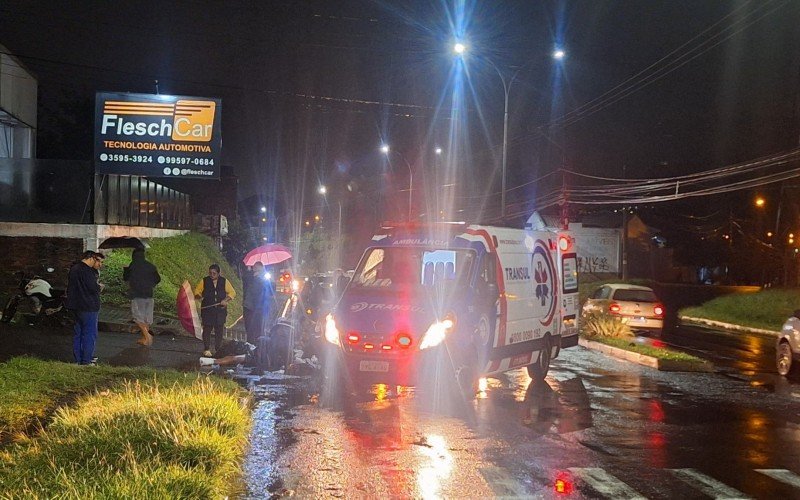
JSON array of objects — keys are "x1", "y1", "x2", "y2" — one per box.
[{"x1": 583, "y1": 283, "x2": 664, "y2": 335}]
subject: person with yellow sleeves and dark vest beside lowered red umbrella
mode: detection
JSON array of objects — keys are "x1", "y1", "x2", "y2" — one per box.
[{"x1": 194, "y1": 264, "x2": 236, "y2": 357}]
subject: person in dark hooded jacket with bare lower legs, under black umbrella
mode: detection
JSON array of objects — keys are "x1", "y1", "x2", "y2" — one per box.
[{"x1": 122, "y1": 248, "x2": 161, "y2": 346}]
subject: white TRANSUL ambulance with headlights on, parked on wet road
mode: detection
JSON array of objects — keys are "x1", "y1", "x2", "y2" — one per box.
[{"x1": 321, "y1": 223, "x2": 579, "y2": 394}]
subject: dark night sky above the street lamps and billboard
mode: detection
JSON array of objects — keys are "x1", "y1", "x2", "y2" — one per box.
[{"x1": 0, "y1": 0, "x2": 800, "y2": 229}]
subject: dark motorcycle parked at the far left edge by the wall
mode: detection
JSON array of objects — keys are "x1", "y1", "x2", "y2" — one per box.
[{"x1": 0, "y1": 269, "x2": 72, "y2": 327}]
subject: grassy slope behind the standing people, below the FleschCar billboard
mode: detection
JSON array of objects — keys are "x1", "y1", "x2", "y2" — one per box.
[{"x1": 100, "y1": 233, "x2": 243, "y2": 324}]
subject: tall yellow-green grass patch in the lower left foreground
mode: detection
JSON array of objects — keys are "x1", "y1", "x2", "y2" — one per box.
[{"x1": 0, "y1": 358, "x2": 249, "y2": 498}]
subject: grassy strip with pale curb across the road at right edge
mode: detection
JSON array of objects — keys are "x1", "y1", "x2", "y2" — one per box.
[{"x1": 678, "y1": 288, "x2": 800, "y2": 331}]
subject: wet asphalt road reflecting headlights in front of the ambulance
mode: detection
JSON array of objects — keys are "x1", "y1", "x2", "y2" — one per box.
[{"x1": 243, "y1": 330, "x2": 800, "y2": 499}]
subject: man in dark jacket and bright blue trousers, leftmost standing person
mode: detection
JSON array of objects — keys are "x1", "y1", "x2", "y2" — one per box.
[{"x1": 66, "y1": 250, "x2": 105, "y2": 365}]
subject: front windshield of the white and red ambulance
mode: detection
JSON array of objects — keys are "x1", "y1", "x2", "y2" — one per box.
[{"x1": 352, "y1": 247, "x2": 475, "y2": 289}]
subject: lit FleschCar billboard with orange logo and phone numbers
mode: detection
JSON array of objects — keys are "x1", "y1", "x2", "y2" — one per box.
[{"x1": 94, "y1": 92, "x2": 222, "y2": 179}]
